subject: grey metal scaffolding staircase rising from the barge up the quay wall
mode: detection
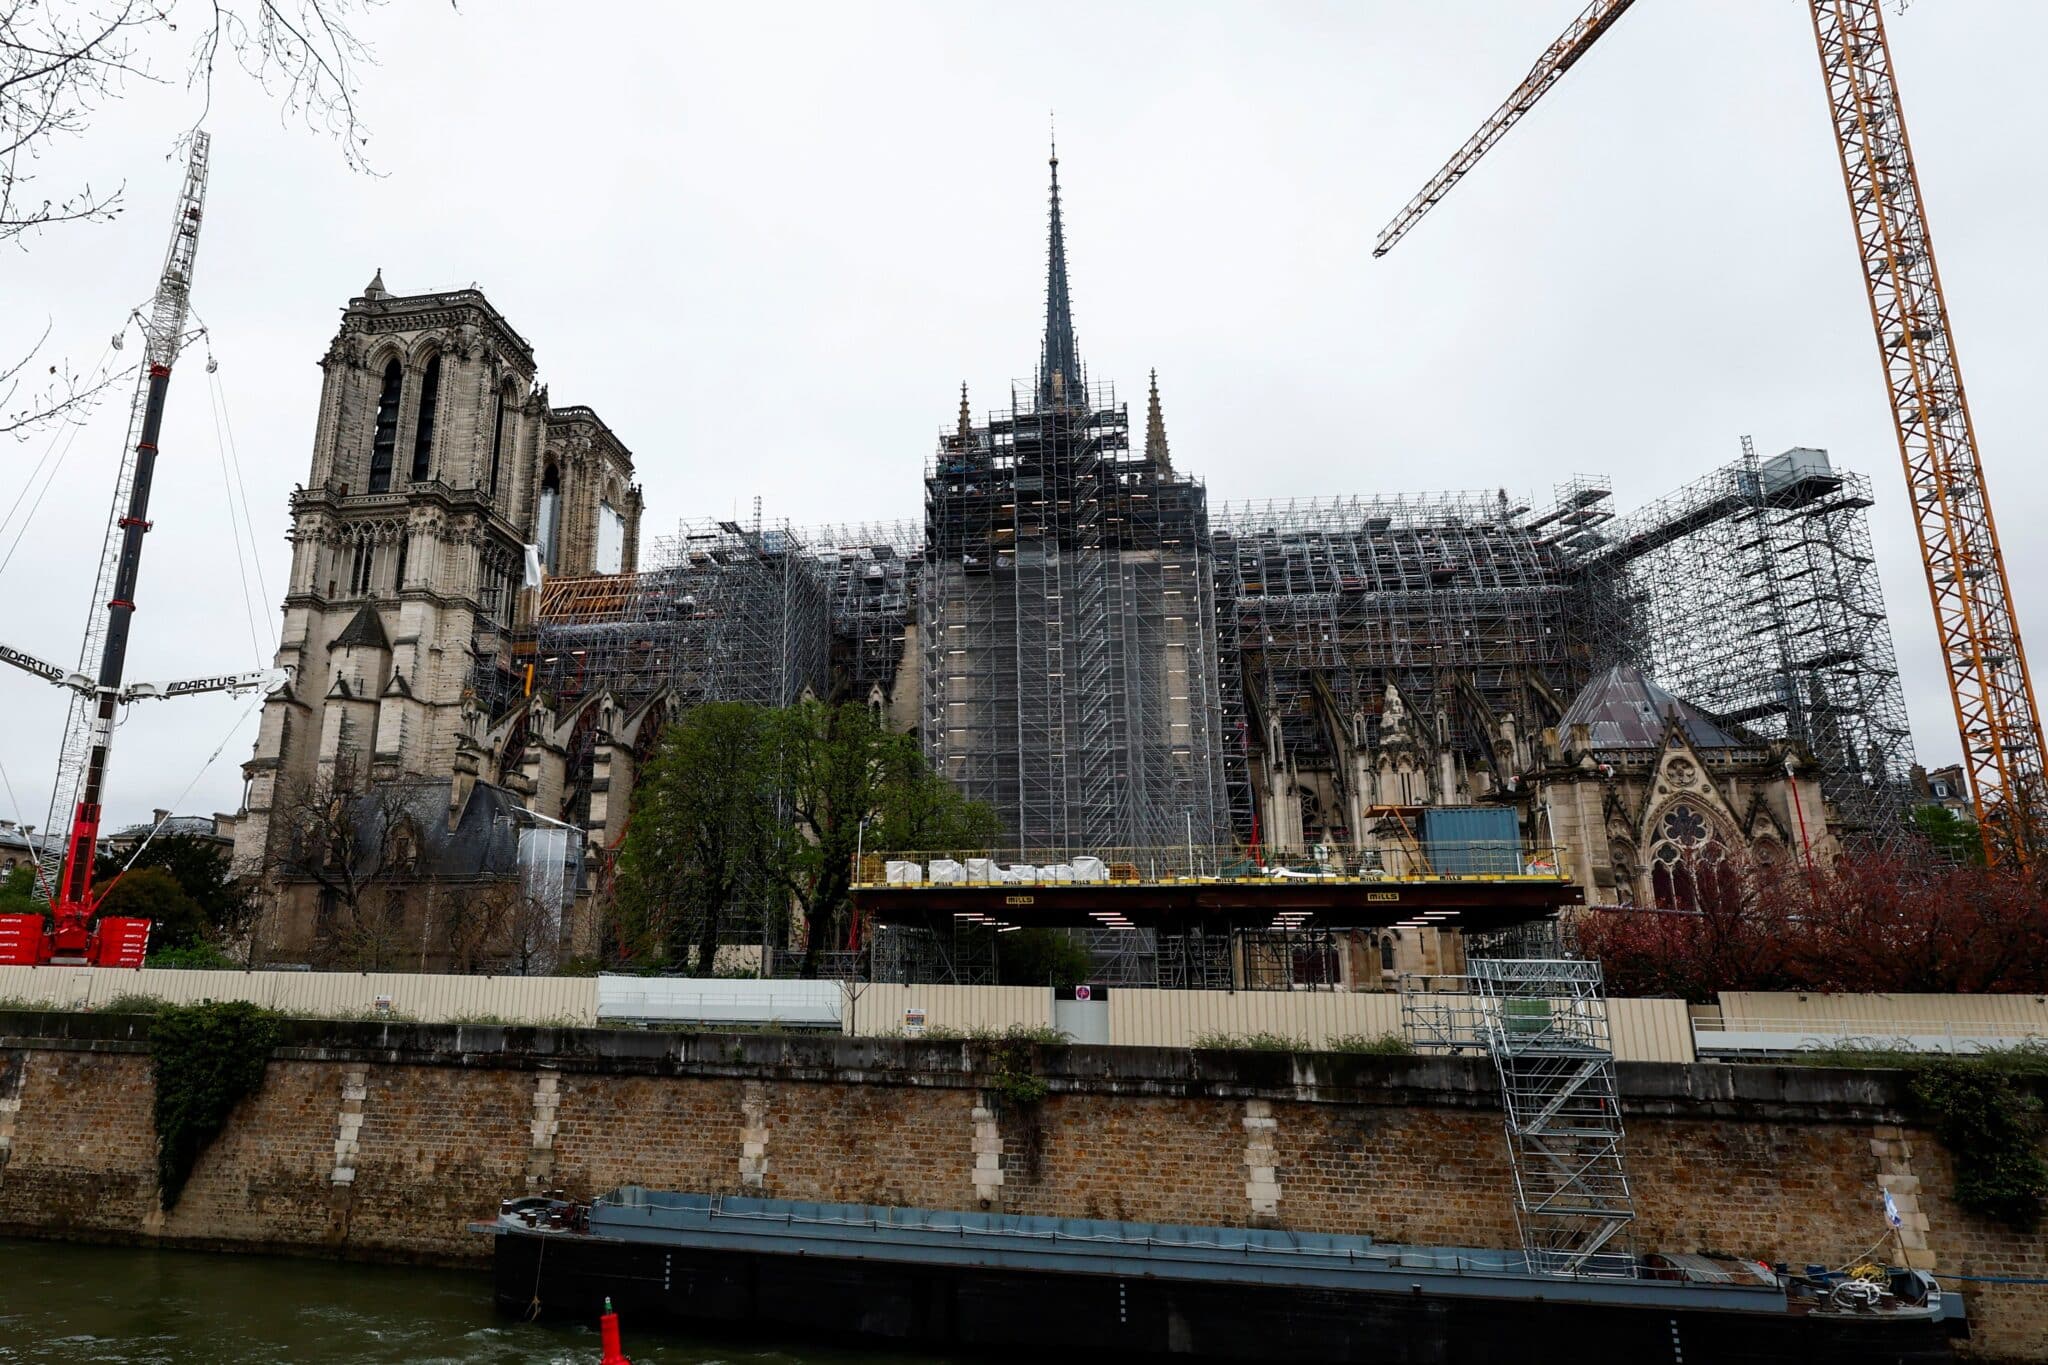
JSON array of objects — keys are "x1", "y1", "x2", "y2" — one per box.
[{"x1": 1401, "y1": 958, "x2": 1634, "y2": 1277}]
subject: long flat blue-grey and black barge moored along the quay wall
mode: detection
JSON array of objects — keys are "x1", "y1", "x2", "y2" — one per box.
[{"x1": 473, "y1": 1185, "x2": 1966, "y2": 1365}]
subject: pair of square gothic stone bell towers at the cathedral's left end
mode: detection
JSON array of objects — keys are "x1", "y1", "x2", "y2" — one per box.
[{"x1": 236, "y1": 272, "x2": 641, "y2": 896}]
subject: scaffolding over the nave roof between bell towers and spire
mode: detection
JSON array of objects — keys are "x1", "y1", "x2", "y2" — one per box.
[{"x1": 514, "y1": 516, "x2": 829, "y2": 706}]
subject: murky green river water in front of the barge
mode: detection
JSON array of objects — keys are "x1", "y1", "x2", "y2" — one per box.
[{"x1": 0, "y1": 1238, "x2": 944, "y2": 1365}]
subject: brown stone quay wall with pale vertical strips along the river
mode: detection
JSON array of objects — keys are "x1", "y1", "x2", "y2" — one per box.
[{"x1": 0, "y1": 1011, "x2": 2048, "y2": 1361}]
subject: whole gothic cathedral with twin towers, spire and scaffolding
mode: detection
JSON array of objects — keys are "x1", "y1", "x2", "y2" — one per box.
[{"x1": 236, "y1": 156, "x2": 1911, "y2": 986}]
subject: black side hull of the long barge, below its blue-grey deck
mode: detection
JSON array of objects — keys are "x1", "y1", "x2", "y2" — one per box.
[{"x1": 494, "y1": 1230, "x2": 1956, "y2": 1365}]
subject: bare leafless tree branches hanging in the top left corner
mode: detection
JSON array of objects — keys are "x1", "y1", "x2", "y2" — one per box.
[{"x1": 0, "y1": 0, "x2": 381, "y2": 438}]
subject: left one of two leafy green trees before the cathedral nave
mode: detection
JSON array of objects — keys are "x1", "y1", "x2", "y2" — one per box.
[{"x1": 618, "y1": 702, "x2": 784, "y2": 976}]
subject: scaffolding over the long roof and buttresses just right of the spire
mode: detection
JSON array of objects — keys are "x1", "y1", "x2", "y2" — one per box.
[{"x1": 1212, "y1": 493, "x2": 1614, "y2": 847}]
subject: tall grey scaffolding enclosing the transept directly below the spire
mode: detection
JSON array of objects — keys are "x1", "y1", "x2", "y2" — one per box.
[{"x1": 918, "y1": 387, "x2": 1229, "y2": 849}]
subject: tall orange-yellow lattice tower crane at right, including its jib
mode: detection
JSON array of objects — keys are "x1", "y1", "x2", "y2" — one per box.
[{"x1": 1372, "y1": 0, "x2": 2048, "y2": 866}]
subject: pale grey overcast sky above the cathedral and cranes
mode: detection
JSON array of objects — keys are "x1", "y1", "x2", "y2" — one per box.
[{"x1": 0, "y1": 0, "x2": 2048, "y2": 825}]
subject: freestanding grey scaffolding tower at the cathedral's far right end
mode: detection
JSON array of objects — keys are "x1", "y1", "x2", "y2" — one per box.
[{"x1": 1571, "y1": 438, "x2": 1913, "y2": 843}]
